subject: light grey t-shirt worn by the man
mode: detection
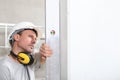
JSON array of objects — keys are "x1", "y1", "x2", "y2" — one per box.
[{"x1": 0, "y1": 56, "x2": 39, "y2": 80}]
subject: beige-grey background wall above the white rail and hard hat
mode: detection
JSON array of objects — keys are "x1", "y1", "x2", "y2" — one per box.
[{"x1": 0, "y1": 0, "x2": 45, "y2": 26}]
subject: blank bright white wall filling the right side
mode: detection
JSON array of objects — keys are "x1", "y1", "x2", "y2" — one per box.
[{"x1": 68, "y1": 0, "x2": 120, "y2": 80}]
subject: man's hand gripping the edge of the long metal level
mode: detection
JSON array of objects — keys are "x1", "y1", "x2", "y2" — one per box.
[{"x1": 40, "y1": 43, "x2": 53, "y2": 63}]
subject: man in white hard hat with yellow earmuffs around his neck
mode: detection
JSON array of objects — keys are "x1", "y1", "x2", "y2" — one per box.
[{"x1": 0, "y1": 22, "x2": 52, "y2": 80}]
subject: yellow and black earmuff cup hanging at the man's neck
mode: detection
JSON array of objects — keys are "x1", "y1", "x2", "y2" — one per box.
[{"x1": 17, "y1": 52, "x2": 34, "y2": 65}]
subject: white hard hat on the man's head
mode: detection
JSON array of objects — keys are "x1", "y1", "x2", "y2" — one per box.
[{"x1": 8, "y1": 22, "x2": 40, "y2": 46}]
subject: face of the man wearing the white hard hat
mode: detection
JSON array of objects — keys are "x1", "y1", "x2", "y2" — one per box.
[{"x1": 17, "y1": 30, "x2": 37, "y2": 53}]
